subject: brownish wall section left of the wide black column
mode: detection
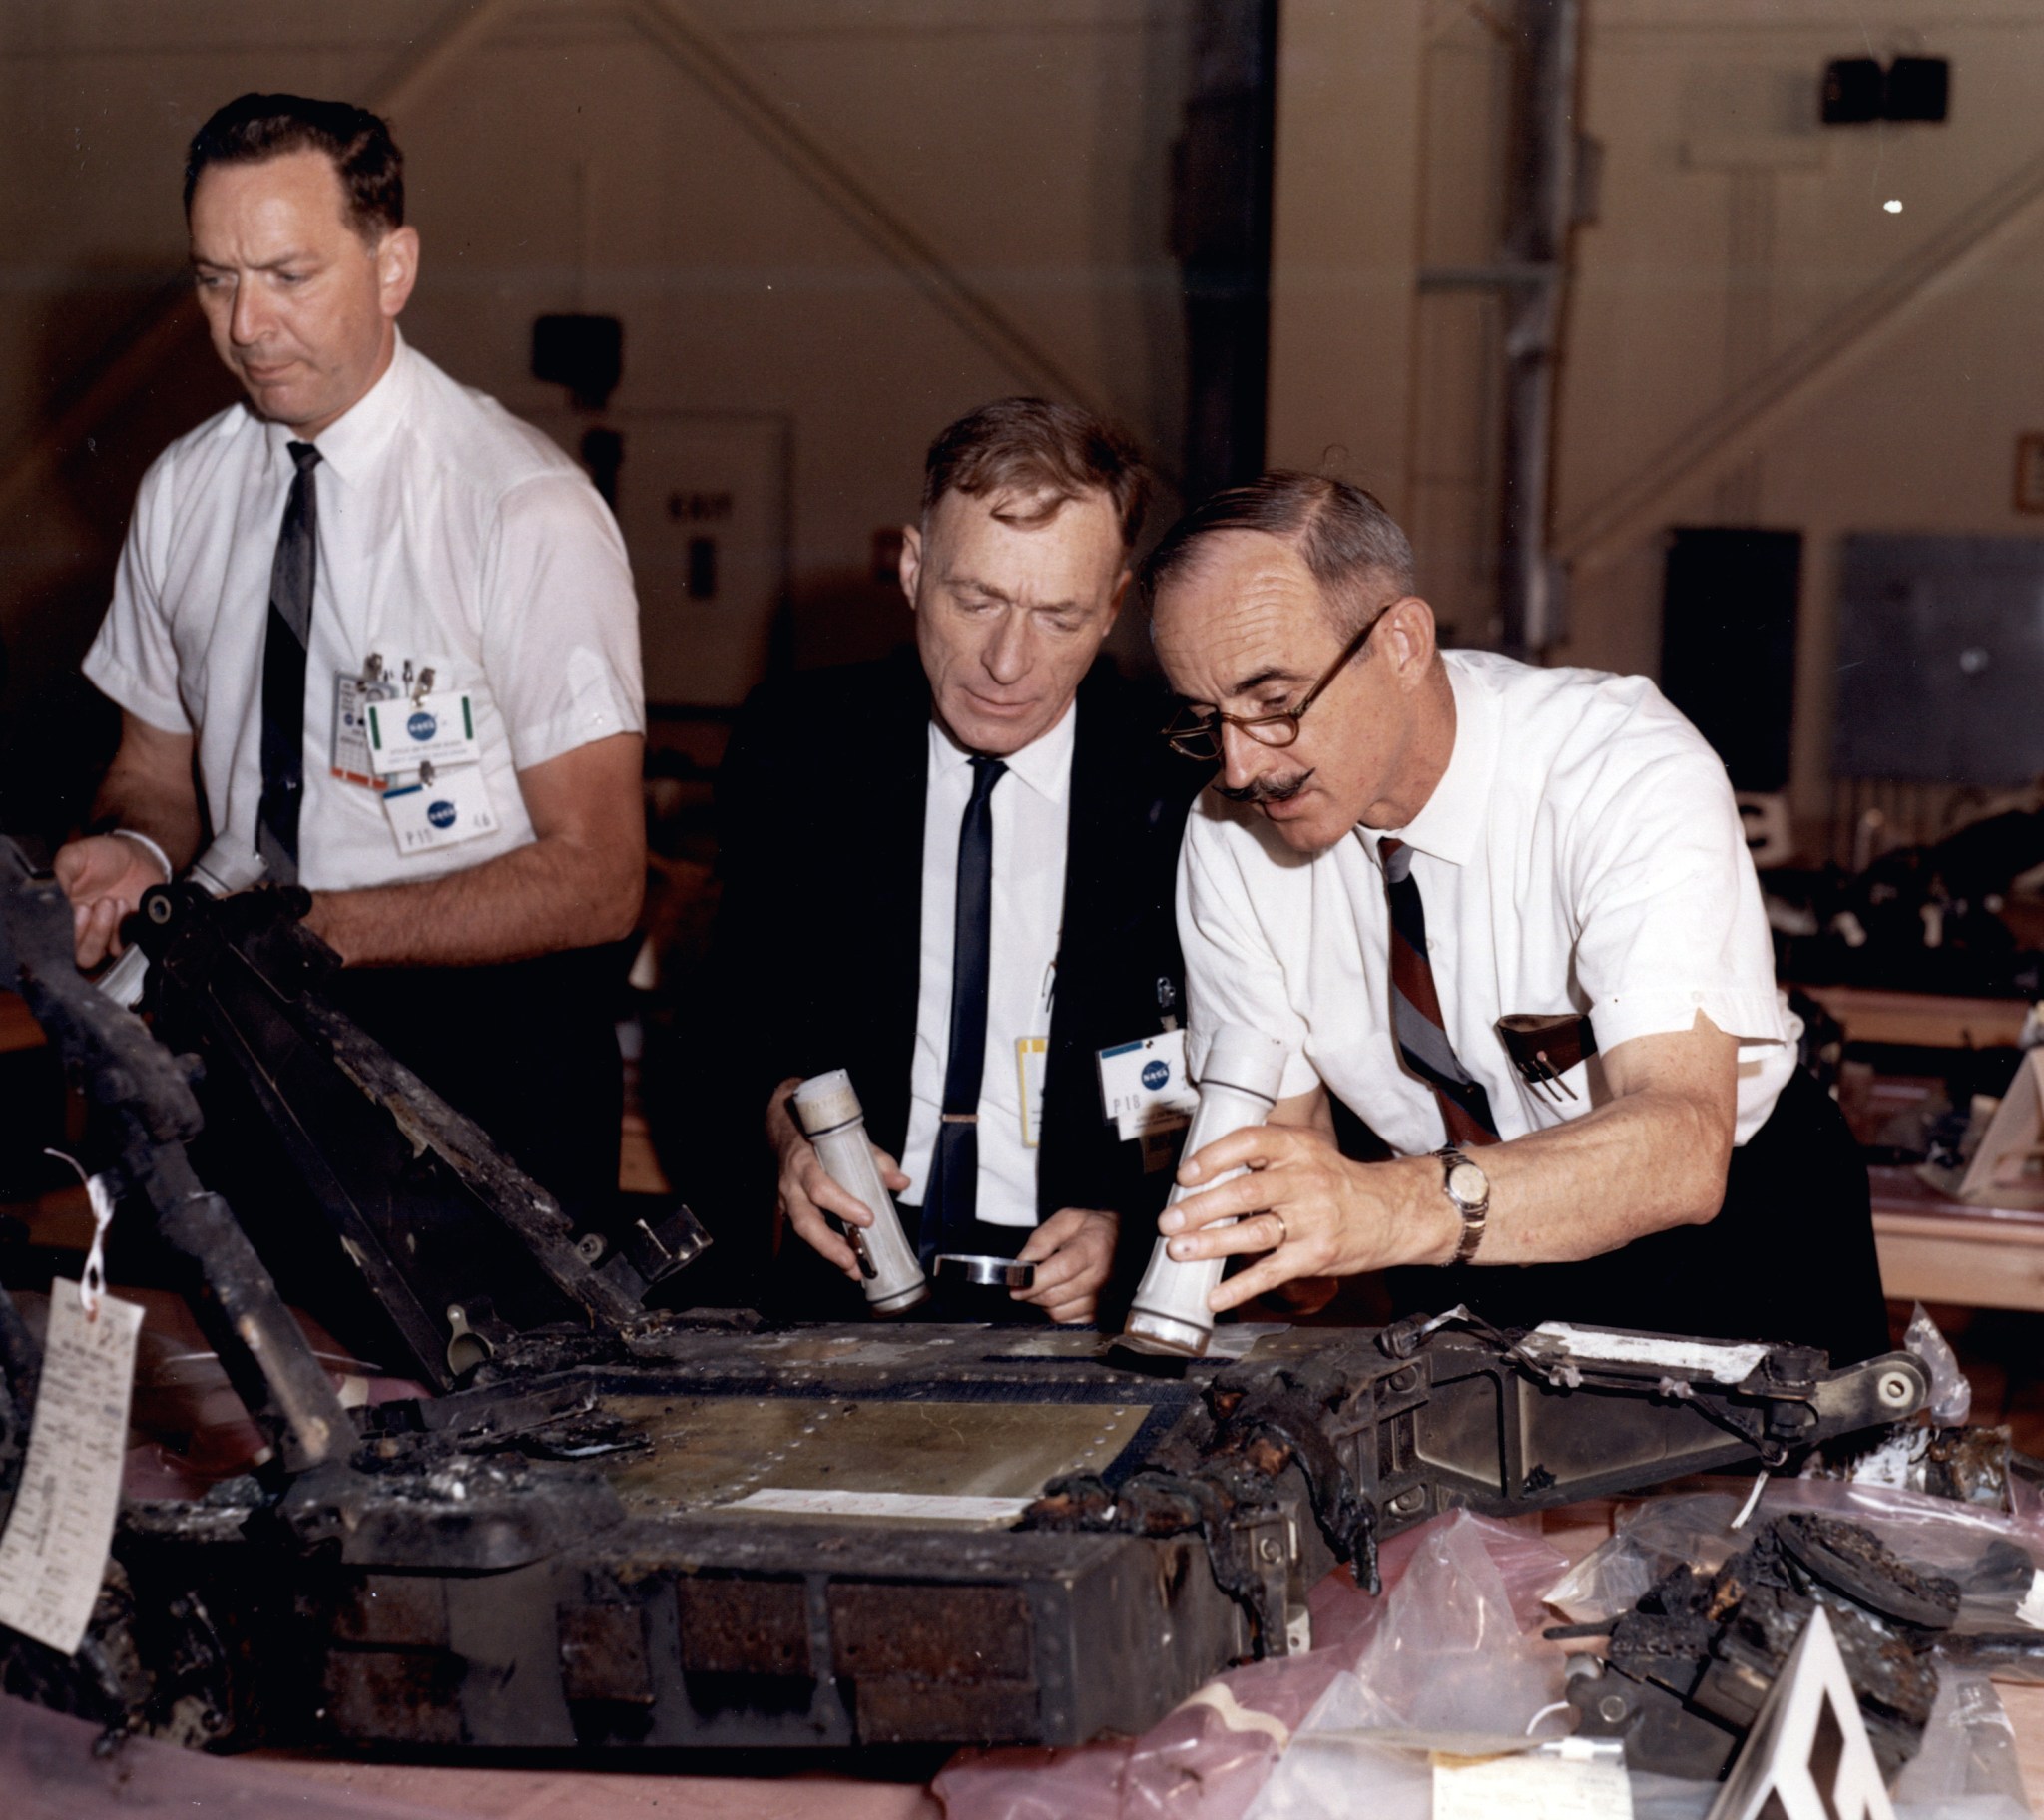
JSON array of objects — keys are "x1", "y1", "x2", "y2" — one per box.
[{"x1": 0, "y1": 0, "x2": 1188, "y2": 743}]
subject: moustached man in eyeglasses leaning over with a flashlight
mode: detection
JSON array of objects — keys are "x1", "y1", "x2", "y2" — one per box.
[{"x1": 1147, "y1": 474, "x2": 1886, "y2": 1360}]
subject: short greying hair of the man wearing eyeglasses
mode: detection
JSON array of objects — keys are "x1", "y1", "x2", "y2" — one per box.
[{"x1": 1143, "y1": 468, "x2": 1412, "y2": 638}]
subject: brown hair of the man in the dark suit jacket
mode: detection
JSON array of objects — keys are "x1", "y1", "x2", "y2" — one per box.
[{"x1": 922, "y1": 398, "x2": 1151, "y2": 548}]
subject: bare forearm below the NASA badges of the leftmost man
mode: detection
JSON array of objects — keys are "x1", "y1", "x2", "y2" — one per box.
[{"x1": 304, "y1": 839, "x2": 646, "y2": 966}]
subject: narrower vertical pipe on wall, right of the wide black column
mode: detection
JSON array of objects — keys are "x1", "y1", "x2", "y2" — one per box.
[{"x1": 1498, "y1": 0, "x2": 1582, "y2": 656}]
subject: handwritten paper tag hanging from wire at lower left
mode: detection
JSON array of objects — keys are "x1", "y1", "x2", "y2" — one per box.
[{"x1": 0, "y1": 1276, "x2": 141, "y2": 1656}]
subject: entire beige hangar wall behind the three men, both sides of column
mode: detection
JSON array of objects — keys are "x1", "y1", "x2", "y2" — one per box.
[{"x1": 0, "y1": 0, "x2": 2044, "y2": 841}]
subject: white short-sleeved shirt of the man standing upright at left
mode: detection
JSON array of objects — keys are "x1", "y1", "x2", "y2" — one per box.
[{"x1": 84, "y1": 337, "x2": 646, "y2": 891}]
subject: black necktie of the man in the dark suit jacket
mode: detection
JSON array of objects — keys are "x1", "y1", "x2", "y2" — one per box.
[{"x1": 922, "y1": 757, "x2": 1008, "y2": 1264}]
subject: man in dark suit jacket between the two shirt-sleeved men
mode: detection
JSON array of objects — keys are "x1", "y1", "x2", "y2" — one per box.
[{"x1": 712, "y1": 398, "x2": 1198, "y2": 1321}]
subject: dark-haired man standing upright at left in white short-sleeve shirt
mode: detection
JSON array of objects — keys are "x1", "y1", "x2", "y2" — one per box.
[{"x1": 55, "y1": 94, "x2": 644, "y2": 1225}]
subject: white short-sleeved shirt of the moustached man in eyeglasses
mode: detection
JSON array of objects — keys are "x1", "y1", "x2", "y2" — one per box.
[{"x1": 1178, "y1": 652, "x2": 1800, "y2": 1156}]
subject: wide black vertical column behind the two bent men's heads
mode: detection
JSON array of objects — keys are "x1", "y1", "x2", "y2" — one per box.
[{"x1": 1172, "y1": 0, "x2": 1278, "y2": 503}]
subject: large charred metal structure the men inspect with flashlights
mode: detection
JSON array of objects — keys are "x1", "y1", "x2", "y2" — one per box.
[{"x1": 0, "y1": 843, "x2": 1927, "y2": 1748}]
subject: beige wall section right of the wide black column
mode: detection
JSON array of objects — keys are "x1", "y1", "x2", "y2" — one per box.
[{"x1": 1272, "y1": 0, "x2": 2044, "y2": 815}]
